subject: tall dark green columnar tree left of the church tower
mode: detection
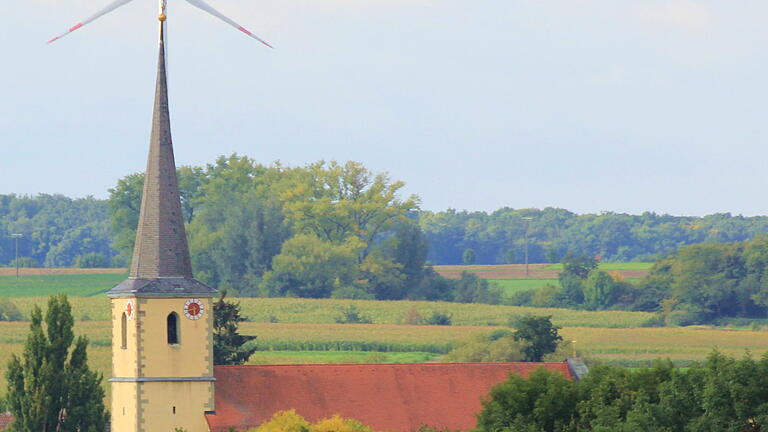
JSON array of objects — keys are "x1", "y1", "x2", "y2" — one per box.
[{"x1": 6, "y1": 295, "x2": 109, "y2": 432}]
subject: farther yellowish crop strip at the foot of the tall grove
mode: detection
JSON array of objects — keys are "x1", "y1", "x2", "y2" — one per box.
[{"x1": 3, "y1": 295, "x2": 655, "y2": 327}]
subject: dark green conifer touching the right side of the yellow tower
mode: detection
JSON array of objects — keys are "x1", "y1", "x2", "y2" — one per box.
[{"x1": 213, "y1": 290, "x2": 256, "y2": 365}]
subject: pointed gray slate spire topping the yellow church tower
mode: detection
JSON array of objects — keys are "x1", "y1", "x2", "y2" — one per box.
[{"x1": 107, "y1": 35, "x2": 216, "y2": 297}]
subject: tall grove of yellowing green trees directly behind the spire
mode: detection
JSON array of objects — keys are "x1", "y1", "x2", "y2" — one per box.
[{"x1": 108, "y1": 155, "x2": 492, "y2": 302}]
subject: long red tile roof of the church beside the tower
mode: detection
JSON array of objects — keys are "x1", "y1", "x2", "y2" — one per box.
[{"x1": 206, "y1": 363, "x2": 571, "y2": 432}]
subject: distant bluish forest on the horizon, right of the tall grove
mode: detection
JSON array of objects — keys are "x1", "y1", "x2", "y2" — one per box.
[{"x1": 418, "y1": 207, "x2": 768, "y2": 265}]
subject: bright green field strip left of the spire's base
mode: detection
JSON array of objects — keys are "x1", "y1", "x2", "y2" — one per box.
[{"x1": 0, "y1": 274, "x2": 126, "y2": 297}]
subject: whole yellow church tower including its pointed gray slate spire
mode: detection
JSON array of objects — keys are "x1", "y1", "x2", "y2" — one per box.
[{"x1": 107, "y1": 7, "x2": 216, "y2": 432}]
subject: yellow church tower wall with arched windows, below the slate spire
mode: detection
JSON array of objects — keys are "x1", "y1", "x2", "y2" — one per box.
[{"x1": 110, "y1": 297, "x2": 214, "y2": 432}]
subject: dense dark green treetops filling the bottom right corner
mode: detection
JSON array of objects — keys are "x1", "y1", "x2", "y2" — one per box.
[{"x1": 474, "y1": 352, "x2": 768, "y2": 432}]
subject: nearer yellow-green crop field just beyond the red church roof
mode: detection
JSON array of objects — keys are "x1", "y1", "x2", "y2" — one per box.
[{"x1": 0, "y1": 321, "x2": 768, "y2": 394}]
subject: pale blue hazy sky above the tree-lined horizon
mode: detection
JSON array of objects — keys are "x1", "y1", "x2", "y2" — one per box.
[{"x1": 0, "y1": 0, "x2": 768, "y2": 215}]
